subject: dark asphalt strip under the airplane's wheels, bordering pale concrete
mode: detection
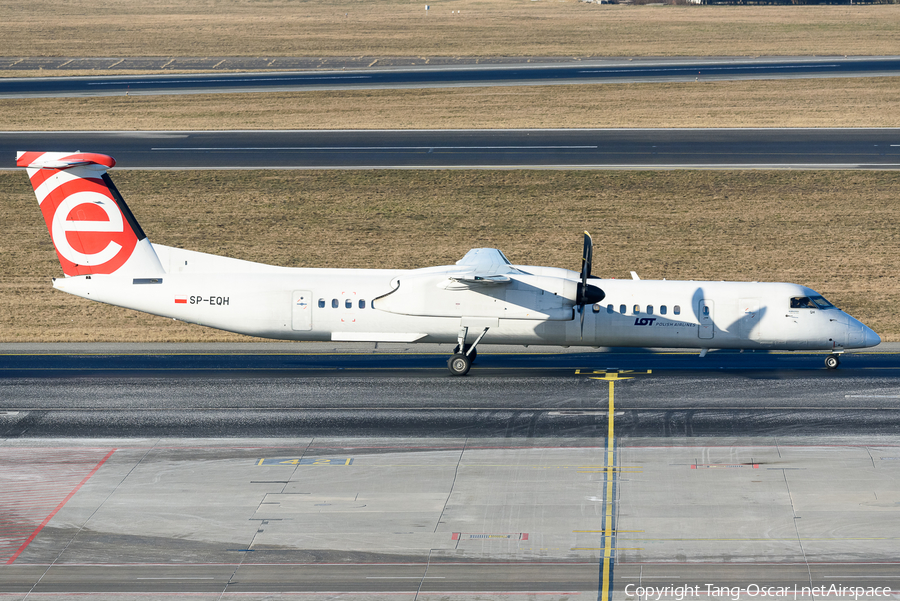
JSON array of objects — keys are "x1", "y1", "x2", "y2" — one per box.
[{"x1": 0, "y1": 347, "x2": 900, "y2": 438}]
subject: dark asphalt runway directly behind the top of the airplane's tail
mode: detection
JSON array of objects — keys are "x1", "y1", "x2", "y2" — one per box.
[{"x1": 7, "y1": 128, "x2": 900, "y2": 169}]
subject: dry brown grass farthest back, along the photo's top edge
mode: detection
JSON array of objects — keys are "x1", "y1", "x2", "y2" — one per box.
[{"x1": 0, "y1": 0, "x2": 900, "y2": 57}]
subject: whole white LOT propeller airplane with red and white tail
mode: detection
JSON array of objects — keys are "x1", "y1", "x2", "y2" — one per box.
[{"x1": 16, "y1": 152, "x2": 881, "y2": 376}]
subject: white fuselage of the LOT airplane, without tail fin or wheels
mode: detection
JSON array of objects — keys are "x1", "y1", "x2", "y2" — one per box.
[{"x1": 54, "y1": 245, "x2": 878, "y2": 350}]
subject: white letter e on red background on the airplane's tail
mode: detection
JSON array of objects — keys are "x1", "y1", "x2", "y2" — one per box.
[{"x1": 35, "y1": 172, "x2": 138, "y2": 275}]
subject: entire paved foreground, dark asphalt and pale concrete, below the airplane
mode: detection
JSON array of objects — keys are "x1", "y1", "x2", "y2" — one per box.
[{"x1": 0, "y1": 343, "x2": 900, "y2": 601}]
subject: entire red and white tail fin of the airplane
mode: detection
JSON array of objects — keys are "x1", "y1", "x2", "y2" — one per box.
[{"x1": 16, "y1": 152, "x2": 164, "y2": 276}]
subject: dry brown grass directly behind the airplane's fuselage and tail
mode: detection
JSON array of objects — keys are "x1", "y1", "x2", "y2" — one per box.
[{"x1": 0, "y1": 171, "x2": 900, "y2": 341}]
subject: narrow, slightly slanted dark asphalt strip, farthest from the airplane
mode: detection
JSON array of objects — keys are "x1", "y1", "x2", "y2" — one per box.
[{"x1": 0, "y1": 57, "x2": 900, "y2": 98}]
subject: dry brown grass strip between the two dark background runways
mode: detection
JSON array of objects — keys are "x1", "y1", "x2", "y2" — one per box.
[{"x1": 0, "y1": 77, "x2": 900, "y2": 130}]
